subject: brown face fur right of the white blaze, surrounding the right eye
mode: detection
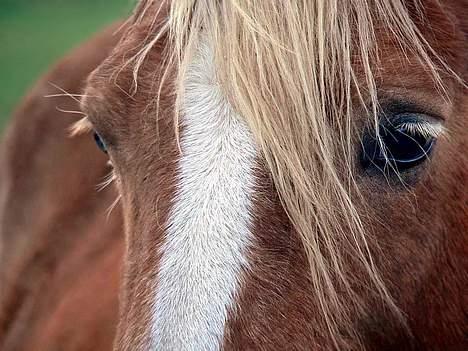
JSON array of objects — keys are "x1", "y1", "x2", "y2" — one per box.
[{"x1": 225, "y1": 2, "x2": 468, "y2": 351}]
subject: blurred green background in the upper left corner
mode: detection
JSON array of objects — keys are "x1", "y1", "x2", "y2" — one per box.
[{"x1": 0, "y1": 0, "x2": 134, "y2": 129}]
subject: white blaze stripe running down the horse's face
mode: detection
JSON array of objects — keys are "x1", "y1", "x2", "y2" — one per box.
[{"x1": 151, "y1": 40, "x2": 256, "y2": 351}]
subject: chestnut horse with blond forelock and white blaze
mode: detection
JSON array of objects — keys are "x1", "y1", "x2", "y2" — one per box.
[{"x1": 0, "y1": 0, "x2": 468, "y2": 351}]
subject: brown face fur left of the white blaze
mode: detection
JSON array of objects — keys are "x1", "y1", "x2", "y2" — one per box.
[{"x1": 83, "y1": 14, "x2": 178, "y2": 351}]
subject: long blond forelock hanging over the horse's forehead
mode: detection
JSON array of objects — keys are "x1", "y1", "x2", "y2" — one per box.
[{"x1": 130, "y1": 0, "x2": 456, "y2": 349}]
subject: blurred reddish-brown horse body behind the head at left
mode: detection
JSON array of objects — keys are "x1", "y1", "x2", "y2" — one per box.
[{"x1": 0, "y1": 27, "x2": 123, "y2": 351}]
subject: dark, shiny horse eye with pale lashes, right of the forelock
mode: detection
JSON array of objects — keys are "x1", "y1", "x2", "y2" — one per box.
[{"x1": 361, "y1": 113, "x2": 442, "y2": 172}]
